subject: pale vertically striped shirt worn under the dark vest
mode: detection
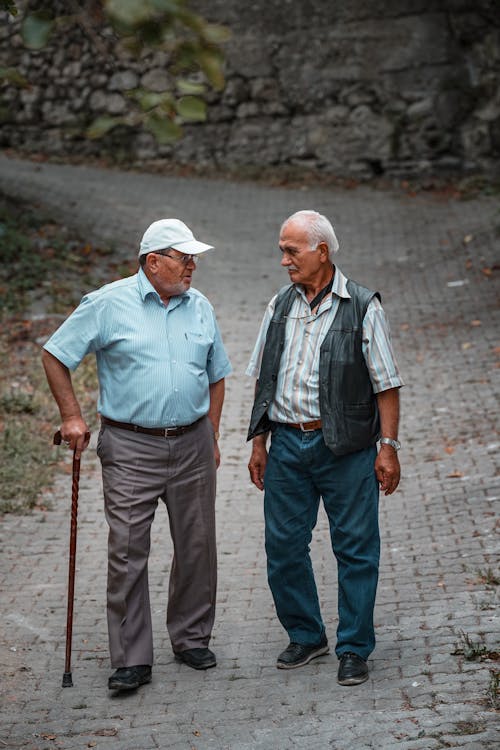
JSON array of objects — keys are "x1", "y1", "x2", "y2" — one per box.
[{"x1": 246, "y1": 267, "x2": 404, "y2": 422}]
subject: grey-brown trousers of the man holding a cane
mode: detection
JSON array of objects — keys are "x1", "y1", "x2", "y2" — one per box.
[{"x1": 97, "y1": 417, "x2": 217, "y2": 668}]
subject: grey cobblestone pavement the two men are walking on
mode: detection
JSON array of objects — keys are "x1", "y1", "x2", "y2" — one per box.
[{"x1": 0, "y1": 157, "x2": 500, "y2": 750}]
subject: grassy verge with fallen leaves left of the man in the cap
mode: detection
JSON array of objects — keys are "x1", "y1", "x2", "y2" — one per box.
[{"x1": 0, "y1": 193, "x2": 111, "y2": 514}]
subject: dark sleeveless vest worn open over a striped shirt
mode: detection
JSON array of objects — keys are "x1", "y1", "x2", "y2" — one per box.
[{"x1": 247, "y1": 280, "x2": 380, "y2": 456}]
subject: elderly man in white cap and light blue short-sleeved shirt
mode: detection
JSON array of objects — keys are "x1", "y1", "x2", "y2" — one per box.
[{"x1": 43, "y1": 219, "x2": 231, "y2": 690}]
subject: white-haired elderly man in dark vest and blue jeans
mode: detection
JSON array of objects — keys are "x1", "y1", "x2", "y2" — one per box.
[{"x1": 247, "y1": 211, "x2": 403, "y2": 685}]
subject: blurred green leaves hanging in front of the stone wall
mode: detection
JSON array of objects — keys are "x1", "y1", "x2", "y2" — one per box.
[{"x1": 0, "y1": 0, "x2": 229, "y2": 143}]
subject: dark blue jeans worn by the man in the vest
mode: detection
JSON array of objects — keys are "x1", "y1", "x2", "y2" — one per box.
[{"x1": 264, "y1": 425, "x2": 380, "y2": 659}]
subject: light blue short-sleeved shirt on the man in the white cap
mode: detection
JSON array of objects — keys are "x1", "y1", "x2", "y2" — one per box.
[{"x1": 44, "y1": 269, "x2": 231, "y2": 427}]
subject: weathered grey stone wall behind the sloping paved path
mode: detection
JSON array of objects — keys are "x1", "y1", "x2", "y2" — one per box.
[{"x1": 0, "y1": 0, "x2": 500, "y2": 178}]
